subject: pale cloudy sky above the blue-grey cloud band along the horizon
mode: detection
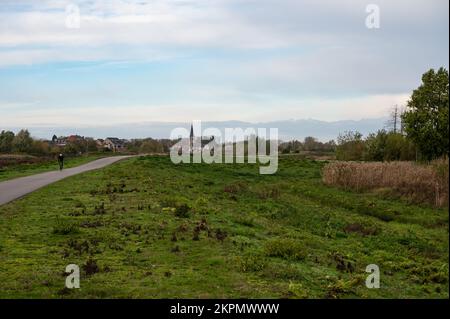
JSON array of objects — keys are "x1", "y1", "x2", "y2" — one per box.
[{"x1": 0, "y1": 0, "x2": 449, "y2": 129}]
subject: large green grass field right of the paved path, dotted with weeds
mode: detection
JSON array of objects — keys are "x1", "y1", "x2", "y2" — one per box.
[{"x1": 0, "y1": 156, "x2": 449, "y2": 298}]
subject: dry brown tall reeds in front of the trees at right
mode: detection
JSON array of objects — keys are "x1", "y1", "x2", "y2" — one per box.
[{"x1": 322, "y1": 159, "x2": 449, "y2": 207}]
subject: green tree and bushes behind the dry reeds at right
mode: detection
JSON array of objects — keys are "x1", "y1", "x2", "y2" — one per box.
[{"x1": 336, "y1": 68, "x2": 449, "y2": 161}]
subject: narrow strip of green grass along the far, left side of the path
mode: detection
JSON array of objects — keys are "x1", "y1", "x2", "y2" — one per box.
[{"x1": 0, "y1": 155, "x2": 105, "y2": 182}]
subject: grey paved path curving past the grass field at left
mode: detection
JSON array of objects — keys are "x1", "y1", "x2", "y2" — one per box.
[{"x1": 0, "y1": 156, "x2": 133, "y2": 205}]
